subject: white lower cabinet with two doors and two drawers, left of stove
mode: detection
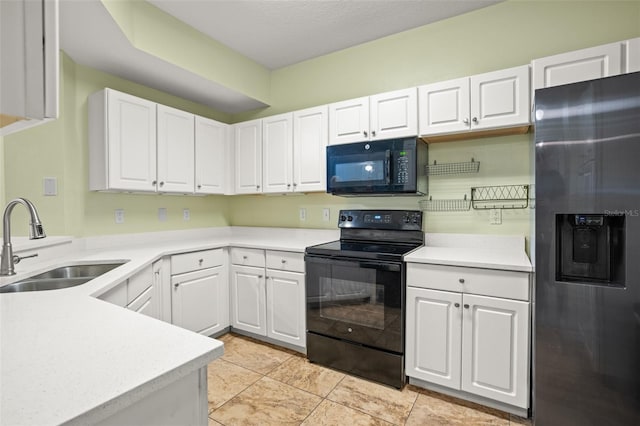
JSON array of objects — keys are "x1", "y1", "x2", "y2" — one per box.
[{"x1": 231, "y1": 248, "x2": 306, "y2": 348}]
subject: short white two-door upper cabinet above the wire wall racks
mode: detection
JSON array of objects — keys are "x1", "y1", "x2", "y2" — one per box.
[{"x1": 418, "y1": 65, "x2": 530, "y2": 135}]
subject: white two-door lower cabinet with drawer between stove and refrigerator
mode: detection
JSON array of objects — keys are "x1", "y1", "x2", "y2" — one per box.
[{"x1": 406, "y1": 265, "x2": 531, "y2": 409}]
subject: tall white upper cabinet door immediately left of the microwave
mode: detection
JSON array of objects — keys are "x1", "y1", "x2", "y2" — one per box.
[{"x1": 293, "y1": 105, "x2": 329, "y2": 192}]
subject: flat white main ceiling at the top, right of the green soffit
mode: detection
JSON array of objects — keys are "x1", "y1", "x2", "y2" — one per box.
[{"x1": 149, "y1": 0, "x2": 501, "y2": 69}]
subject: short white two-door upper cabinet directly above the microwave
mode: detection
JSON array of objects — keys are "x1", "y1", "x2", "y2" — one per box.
[{"x1": 329, "y1": 87, "x2": 418, "y2": 145}]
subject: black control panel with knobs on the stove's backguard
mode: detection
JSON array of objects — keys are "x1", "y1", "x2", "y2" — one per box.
[{"x1": 338, "y1": 210, "x2": 422, "y2": 231}]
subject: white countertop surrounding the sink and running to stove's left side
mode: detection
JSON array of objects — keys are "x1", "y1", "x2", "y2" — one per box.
[{"x1": 0, "y1": 228, "x2": 338, "y2": 426}]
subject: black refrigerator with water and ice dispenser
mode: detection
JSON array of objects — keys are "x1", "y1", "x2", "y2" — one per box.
[{"x1": 533, "y1": 73, "x2": 640, "y2": 426}]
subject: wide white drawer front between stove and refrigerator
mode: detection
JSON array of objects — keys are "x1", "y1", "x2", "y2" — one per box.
[{"x1": 407, "y1": 263, "x2": 529, "y2": 300}]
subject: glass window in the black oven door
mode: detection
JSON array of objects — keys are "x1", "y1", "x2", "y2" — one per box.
[{"x1": 319, "y1": 277, "x2": 385, "y2": 330}]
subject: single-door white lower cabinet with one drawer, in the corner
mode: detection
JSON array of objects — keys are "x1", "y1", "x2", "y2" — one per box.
[{"x1": 171, "y1": 249, "x2": 229, "y2": 336}]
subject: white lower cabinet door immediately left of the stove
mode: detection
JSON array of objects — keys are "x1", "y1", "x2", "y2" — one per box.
[{"x1": 267, "y1": 269, "x2": 306, "y2": 347}]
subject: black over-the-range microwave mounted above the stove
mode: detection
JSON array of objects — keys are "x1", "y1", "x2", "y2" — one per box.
[{"x1": 327, "y1": 138, "x2": 429, "y2": 196}]
